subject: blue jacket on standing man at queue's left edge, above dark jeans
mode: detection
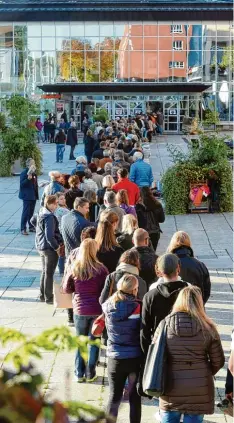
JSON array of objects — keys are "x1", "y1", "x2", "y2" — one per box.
[{"x1": 32, "y1": 207, "x2": 63, "y2": 251}]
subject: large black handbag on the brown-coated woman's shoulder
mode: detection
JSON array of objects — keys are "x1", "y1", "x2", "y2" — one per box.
[{"x1": 142, "y1": 321, "x2": 167, "y2": 398}]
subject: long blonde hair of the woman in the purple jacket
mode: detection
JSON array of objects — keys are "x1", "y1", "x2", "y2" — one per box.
[{"x1": 73, "y1": 238, "x2": 104, "y2": 281}]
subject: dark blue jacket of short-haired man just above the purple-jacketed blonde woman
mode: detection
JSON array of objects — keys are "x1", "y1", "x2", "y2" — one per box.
[{"x1": 61, "y1": 210, "x2": 96, "y2": 257}]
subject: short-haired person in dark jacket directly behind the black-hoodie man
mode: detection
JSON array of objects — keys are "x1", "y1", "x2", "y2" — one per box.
[{"x1": 133, "y1": 229, "x2": 158, "y2": 290}]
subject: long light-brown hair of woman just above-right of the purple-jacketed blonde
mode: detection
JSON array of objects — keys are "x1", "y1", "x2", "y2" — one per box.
[{"x1": 95, "y1": 211, "x2": 119, "y2": 251}]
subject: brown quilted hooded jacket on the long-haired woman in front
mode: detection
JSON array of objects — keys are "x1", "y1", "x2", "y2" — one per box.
[{"x1": 154, "y1": 312, "x2": 225, "y2": 414}]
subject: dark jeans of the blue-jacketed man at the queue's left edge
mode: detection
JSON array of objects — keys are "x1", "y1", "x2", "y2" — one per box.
[{"x1": 39, "y1": 250, "x2": 58, "y2": 301}]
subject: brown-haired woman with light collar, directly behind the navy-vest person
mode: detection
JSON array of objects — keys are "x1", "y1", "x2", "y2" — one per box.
[{"x1": 99, "y1": 248, "x2": 147, "y2": 304}]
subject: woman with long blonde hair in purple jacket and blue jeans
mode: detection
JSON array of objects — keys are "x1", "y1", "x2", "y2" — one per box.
[{"x1": 63, "y1": 238, "x2": 108, "y2": 382}]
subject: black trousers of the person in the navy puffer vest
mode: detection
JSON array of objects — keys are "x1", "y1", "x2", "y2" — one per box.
[{"x1": 107, "y1": 358, "x2": 141, "y2": 423}]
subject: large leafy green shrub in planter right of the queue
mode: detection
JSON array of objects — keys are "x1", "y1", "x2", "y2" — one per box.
[{"x1": 162, "y1": 134, "x2": 233, "y2": 214}]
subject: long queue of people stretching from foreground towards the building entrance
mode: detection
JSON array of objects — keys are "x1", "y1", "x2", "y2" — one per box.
[{"x1": 20, "y1": 116, "x2": 233, "y2": 423}]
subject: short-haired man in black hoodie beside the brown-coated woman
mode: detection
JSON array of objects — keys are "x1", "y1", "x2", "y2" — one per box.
[{"x1": 141, "y1": 253, "x2": 189, "y2": 356}]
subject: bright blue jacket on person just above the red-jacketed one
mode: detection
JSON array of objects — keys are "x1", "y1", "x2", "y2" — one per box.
[{"x1": 129, "y1": 159, "x2": 154, "y2": 187}]
